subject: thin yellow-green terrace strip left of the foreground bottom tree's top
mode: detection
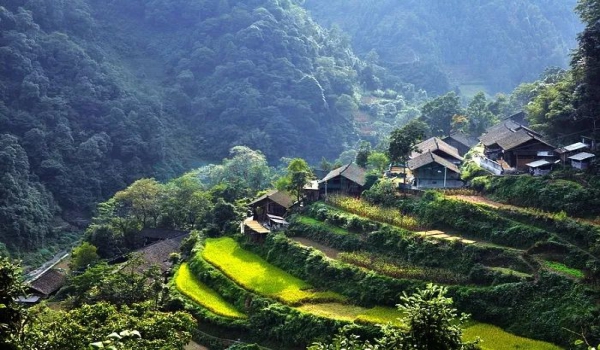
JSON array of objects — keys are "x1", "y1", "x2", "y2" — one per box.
[{"x1": 297, "y1": 303, "x2": 404, "y2": 326}]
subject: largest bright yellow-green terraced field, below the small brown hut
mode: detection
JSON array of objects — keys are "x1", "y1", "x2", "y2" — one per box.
[{"x1": 202, "y1": 237, "x2": 346, "y2": 305}]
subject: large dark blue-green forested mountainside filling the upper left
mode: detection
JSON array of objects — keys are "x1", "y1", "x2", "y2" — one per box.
[{"x1": 0, "y1": 0, "x2": 396, "y2": 258}]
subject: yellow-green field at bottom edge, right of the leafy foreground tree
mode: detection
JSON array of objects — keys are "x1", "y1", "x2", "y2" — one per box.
[{"x1": 463, "y1": 323, "x2": 562, "y2": 350}]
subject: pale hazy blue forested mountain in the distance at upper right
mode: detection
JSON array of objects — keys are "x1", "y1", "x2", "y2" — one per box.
[{"x1": 305, "y1": 0, "x2": 581, "y2": 93}]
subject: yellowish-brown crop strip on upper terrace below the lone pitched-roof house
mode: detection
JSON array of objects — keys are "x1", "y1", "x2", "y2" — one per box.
[{"x1": 327, "y1": 196, "x2": 419, "y2": 231}]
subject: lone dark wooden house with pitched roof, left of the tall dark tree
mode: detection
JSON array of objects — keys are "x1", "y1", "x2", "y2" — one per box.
[{"x1": 319, "y1": 163, "x2": 367, "y2": 196}]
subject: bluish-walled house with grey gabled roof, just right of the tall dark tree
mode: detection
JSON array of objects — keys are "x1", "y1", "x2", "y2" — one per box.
[{"x1": 408, "y1": 151, "x2": 464, "y2": 189}]
